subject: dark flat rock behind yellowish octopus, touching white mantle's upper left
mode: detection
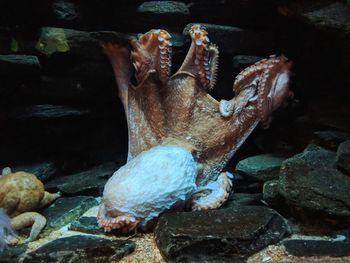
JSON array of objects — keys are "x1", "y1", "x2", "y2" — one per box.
[{"x1": 45, "y1": 162, "x2": 121, "y2": 196}]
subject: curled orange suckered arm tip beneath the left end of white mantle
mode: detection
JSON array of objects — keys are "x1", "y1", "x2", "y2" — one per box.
[{"x1": 97, "y1": 204, "x2": 139, "y2": 233}]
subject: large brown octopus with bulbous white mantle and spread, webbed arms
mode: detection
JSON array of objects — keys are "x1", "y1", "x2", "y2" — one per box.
[{"x1": 97, "y1": 25, "x2": 293, "y2": 232}]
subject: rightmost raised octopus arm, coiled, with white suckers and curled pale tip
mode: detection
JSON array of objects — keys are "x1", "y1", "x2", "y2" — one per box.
[{"x1": 219, "y1": 55, "x2": 291, "y2": 122}]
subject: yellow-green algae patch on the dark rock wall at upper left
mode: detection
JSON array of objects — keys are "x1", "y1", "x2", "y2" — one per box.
[{"x1": 35, "y1": 27, "x2": 70, "y2": 56}]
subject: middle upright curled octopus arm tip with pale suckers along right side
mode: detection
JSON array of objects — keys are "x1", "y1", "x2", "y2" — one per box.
[{"x1": 174, "y1": 25, "x2": 219, "y2": 90}]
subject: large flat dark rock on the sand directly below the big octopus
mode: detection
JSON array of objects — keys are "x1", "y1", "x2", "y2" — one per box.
[{"x1": 155, "y1": 206, "x2": 289, "y2": 262}]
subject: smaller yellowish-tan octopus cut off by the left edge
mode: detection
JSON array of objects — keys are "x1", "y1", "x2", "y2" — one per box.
[{"x1": 0, "y1": 167, "x2": 61, "y2": 242}]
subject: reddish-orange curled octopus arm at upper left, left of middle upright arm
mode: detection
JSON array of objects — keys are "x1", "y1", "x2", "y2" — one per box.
[{"x1": 130, "y1": 29, "x2": 172, "y2": 85}]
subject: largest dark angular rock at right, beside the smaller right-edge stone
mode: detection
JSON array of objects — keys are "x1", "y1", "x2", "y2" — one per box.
[{"x1": 279, "y1": 145, "x2": 350, "y2": 217}]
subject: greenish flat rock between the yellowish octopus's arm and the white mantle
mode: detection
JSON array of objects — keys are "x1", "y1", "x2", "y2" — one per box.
[{"x1": 41, "y1": 196, "x2": 98, "y2": 233}]
